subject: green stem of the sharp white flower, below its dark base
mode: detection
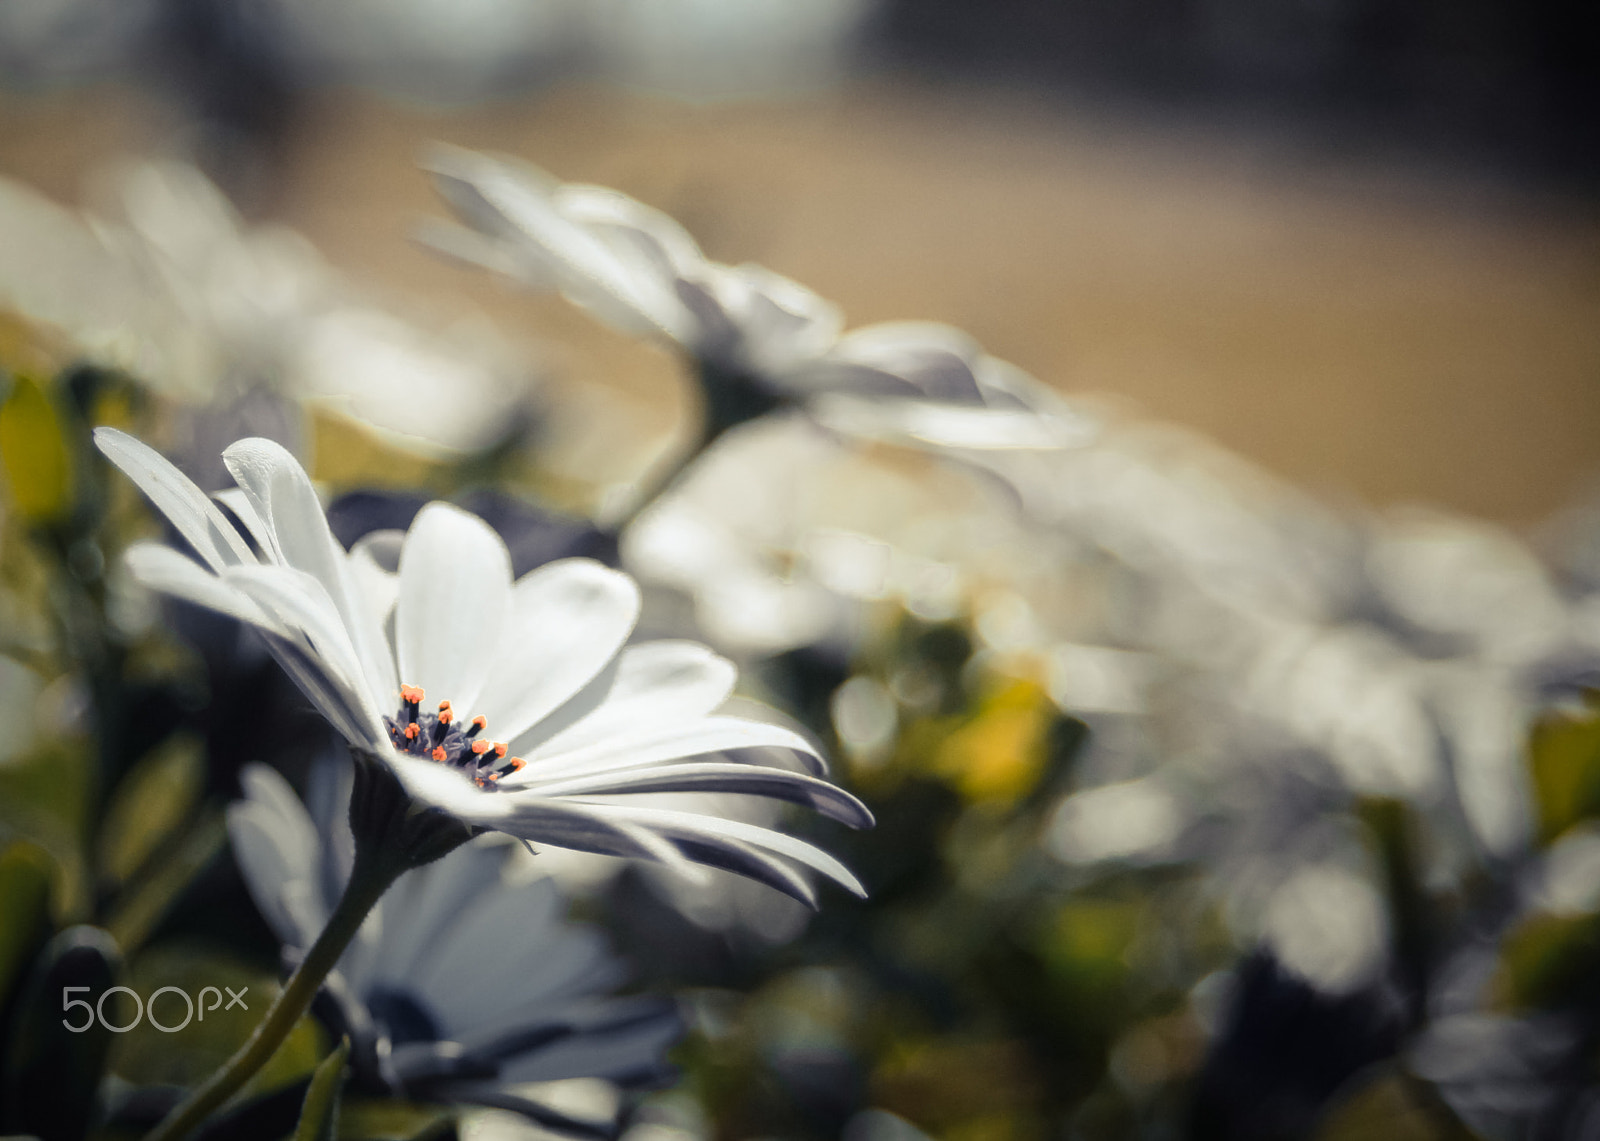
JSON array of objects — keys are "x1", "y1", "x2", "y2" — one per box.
[{"x1": 146, "y1": 850, "x2": 405, "y2": 1141}]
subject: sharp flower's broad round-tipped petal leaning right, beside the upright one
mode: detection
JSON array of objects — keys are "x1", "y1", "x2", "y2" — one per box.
[{"x1": 462, "y1": 558, "x2": 638, "y2": 741}]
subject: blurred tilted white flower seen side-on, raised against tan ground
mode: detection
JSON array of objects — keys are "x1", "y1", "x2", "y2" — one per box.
[{"x1": 427, "y1": 149, "x2": 1088, "y2": 448}]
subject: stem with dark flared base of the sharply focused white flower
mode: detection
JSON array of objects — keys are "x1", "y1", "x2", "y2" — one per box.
[{"x1": 146, "y1": 752, "x2": 469, "y2": 1141}]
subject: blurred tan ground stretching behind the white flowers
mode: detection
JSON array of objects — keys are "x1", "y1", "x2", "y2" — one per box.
[{"x1": 0, "y1": 80, "x2": 1600, "y2": 523}]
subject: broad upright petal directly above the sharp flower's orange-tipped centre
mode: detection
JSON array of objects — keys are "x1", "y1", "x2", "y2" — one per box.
[{"x1": 395, "y1": 502, "x2": 510, "y2": 715}]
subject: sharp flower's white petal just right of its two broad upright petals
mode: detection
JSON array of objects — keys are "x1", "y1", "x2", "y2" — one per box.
[{"x1": 531, "y1": 642, "x2": 738, "y2": 755}]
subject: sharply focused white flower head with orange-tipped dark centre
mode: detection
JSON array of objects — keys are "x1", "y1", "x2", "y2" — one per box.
[{"x1": 96, "y1": 427, "x2": 872, "y2": 903}]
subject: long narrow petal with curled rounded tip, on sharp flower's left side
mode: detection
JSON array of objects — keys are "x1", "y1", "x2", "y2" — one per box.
[{"x1": 222, "y1": 438, "x2": 397, "y2": 701}]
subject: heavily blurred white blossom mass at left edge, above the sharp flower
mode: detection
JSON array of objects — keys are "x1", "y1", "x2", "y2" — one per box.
[{"x1": 0, "y1": 163, "x2": 528, "y2": 451}]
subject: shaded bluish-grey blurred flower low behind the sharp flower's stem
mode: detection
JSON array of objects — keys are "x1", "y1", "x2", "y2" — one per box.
[{"x1": 227, "y1": 763, "x2": 682, "y2": 1131}]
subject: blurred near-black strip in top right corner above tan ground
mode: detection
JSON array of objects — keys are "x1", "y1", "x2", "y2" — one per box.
[{"x1": 877, "y1": 0, "x2": 1600, "y2": 190}]
